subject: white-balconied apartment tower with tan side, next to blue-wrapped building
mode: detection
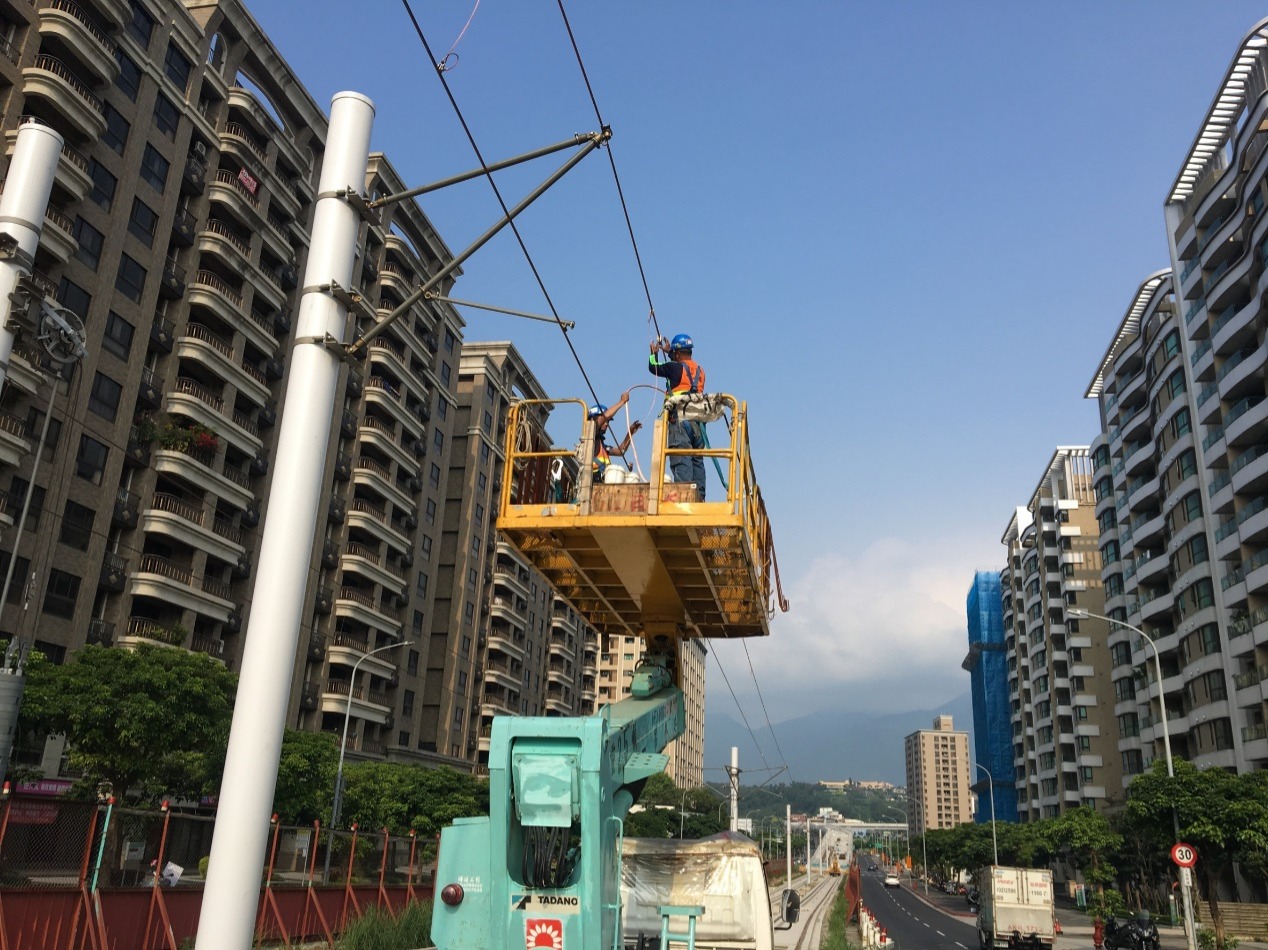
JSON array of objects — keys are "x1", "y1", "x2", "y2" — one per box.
[{"x1": 999, "y1": 446, "x2": 1122, "y2": 821}]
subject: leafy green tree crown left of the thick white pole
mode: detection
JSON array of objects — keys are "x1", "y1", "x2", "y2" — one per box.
[{"x1": 19, "y1": 644, "x2": 237, "y2": 802}]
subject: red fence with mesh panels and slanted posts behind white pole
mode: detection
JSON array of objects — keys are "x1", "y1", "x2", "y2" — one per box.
[{"x1": 0, "y1": 794, "x2": 435, "y2": 950}]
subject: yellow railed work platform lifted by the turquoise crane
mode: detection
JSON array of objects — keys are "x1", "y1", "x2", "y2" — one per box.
[{"x1": 497, "y1": 396, "x2": 787, "y2": 639}]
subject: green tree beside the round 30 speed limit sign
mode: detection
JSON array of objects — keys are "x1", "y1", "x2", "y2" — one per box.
[{"x1": 1127, "y1": 760, "x2": 1268, "y2": 946}]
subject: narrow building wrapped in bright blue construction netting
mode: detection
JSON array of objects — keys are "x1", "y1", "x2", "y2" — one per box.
[{"x1": 964, "y1": 571, "x2": 1017, "y2": 823}]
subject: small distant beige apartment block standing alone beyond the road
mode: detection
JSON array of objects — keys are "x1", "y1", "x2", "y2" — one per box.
[{"x1": 903, "y1": 715, "x2": 973, "y2": 835}]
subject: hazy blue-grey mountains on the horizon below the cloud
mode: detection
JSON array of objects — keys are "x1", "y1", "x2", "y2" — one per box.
[{"x1": 705, "y1": 693, "x2": 973, "y2": 785}]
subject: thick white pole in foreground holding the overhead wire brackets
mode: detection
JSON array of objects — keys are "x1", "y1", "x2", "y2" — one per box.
[{"x1": 195, "y1": 93, "x2": 374, "y2": 950}]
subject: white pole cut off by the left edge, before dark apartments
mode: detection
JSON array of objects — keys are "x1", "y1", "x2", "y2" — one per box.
[{"x1": 0, "y1": 122, "x2": 65, "y2": 393}]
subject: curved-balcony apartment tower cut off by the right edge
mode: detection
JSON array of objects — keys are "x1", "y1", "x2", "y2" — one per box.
[{"x1": 1144, "y1": 20, "x2": 1268, "y2": 771}]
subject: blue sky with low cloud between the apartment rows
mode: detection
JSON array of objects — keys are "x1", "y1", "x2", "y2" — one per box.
[{"x1": 250, "y1": 0, "x2": 1264, "y2": 727}]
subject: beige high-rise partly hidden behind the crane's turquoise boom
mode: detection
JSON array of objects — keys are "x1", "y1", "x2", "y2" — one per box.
[{"x1": 597, "y1": 637, "x2": 705, "y2": 788}]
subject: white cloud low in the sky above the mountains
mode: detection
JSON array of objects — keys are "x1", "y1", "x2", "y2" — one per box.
[{"x1": 708, "y1": 538, "x2": 1002, "y2": 722}]
